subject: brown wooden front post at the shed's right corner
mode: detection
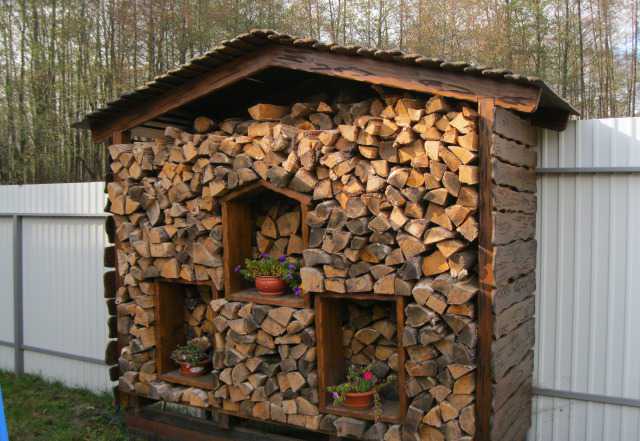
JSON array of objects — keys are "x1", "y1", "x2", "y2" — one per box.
[{"x1": 476, "y1": 98, "x2": 495, "y2": 441}]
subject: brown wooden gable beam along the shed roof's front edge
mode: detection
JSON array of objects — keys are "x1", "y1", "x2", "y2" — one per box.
[{"x1": 91, "y1": 46, "x2": 542, "y2": 142}]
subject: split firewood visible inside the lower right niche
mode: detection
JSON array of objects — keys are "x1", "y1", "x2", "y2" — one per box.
[{"x1": 342, "y1": 302, "x2": 400, "y2": 388}]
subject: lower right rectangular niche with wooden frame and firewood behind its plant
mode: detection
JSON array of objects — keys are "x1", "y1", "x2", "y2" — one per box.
[{"x1": 315, "y1": 294, "x2": 407, "y2": 423}]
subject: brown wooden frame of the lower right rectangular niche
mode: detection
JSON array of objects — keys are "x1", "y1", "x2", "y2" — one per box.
[{"x1": 315, "y1": 292, "x2": 408, "y2": 424}]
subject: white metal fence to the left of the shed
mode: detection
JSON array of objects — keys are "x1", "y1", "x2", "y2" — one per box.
[{"x1": 0, "y1": 182, "x2": 111, "y2": 391}]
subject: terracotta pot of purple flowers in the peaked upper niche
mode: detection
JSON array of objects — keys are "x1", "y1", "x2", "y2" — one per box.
[{"x1": 235, "y1": 253, "x2": 301, "y2": 296}]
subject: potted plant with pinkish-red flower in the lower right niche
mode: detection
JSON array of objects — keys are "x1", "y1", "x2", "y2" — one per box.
[{"x1": 327, "y1": 366, "x2": 381, "y2": 409}]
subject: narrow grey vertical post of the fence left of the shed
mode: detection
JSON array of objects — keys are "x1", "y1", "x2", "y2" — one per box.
[{"x1": 13, "y1": 215, "x2": 24, "y2": 375}]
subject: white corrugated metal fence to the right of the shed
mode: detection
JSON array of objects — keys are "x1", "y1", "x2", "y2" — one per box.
[{"x1": 529, "y1": 118, "x2": 640, "y2": 441}]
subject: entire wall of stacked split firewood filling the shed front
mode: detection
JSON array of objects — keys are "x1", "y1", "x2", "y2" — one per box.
[{"x1": 107, "y1": 93, "x2": 479, "y2": 440}]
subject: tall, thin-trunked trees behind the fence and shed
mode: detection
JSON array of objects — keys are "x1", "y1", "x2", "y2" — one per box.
[{"x1": 0, "y1": 0, "x2": 638, "y2": 184}]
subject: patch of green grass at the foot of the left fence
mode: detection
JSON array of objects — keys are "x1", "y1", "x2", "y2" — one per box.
[{"x1": 0, "y1": 371, "x2": 130, "y2": 441}]
